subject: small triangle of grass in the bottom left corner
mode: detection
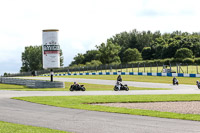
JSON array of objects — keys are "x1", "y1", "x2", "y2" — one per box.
[{"x1": 0, "y1": 121, "x2": 67, "y2": 133}]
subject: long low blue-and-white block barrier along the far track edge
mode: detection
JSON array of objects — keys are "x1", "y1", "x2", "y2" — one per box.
[{"x1": 42, "y1": 72, "x2": 200, "y2": 77}]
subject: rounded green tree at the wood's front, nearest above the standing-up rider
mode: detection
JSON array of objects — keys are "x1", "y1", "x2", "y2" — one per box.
[{"x1": 124, "y1": 48, "x2": 142, "y2": 63}]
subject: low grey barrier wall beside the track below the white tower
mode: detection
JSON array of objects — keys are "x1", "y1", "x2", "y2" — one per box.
[{"x1": 0, "y1": 77, "x2": 65, "y2": 88}]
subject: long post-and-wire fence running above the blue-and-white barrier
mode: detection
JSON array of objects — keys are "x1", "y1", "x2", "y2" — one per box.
[{"x1": 4, "y1": 63, "x2": 199, "y2": 77}]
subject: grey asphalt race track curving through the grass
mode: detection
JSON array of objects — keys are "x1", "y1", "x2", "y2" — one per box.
[{"x1": 0, "y1": 78, "x2": 200, "y2": 133}]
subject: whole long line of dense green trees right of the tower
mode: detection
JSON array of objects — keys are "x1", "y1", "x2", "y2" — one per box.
[{"x1": 70, "y1": 29, "x2": 200, "y2": 66}]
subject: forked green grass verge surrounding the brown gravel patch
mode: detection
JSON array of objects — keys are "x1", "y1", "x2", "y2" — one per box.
[{"x1": 14, "y1": 94, "x2": 200, "y2": 121}]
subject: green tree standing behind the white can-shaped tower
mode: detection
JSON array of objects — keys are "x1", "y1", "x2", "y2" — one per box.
[{"x1": 20, "y1": 46, "x2": 63, "y2": 72}]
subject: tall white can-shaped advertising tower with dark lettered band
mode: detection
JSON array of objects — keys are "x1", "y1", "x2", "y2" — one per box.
[{"x1": 42, "y1": 29, "x2": 60, "y2": 69}]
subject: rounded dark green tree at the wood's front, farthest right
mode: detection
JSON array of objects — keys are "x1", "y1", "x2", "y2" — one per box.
[{"x1": 175, "y1": 48, "x2": 193, "y2": 59}]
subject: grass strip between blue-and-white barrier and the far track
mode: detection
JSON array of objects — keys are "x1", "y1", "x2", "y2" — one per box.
[{"x1": 56, "y1": 75, "x2": 200, "y2": 85}]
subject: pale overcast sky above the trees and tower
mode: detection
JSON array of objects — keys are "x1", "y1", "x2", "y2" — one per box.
[{"x1": 0, "y1": 0, "x2": 200, "y2": 75}]
